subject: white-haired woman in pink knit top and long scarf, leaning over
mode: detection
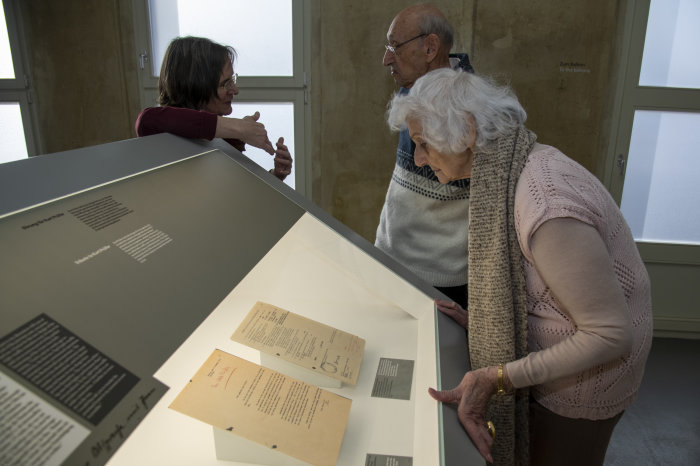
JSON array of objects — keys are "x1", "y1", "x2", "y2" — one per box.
[{"x1": 388, "y1": 69, "x2": 652, "y2": 465}]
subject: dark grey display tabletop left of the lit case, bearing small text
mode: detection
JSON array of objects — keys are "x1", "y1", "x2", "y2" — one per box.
[{"x1": 0, "y1": 152, "x2": 303, "y2": 376}]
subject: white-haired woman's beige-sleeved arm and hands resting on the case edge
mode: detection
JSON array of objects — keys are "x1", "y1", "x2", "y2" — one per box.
[{"x1": 429, "y1": 218, "x2": 632, "y2": 461}]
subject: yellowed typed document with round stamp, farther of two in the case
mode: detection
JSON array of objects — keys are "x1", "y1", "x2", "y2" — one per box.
[{"x1": 231, "y1": 302, "x2": 365, "y2": 385}]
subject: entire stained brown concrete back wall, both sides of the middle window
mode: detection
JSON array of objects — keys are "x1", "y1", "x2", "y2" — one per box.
[{"x1": 20, "y1": 0, "x2": 622, "y2": 241}]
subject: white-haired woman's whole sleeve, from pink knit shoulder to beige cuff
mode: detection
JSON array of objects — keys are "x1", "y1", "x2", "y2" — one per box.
[{"x1": 506, "y1": 148, "x2": 632, "y2": 388}]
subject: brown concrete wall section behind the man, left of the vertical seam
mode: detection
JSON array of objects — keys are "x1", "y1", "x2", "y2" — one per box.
[{"x1": 311, "y1": 0, "x2": 473, "y2": 242}]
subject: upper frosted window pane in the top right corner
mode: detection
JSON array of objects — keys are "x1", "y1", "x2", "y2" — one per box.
[{"x1": 639, "y1": 0, "x2": 700, "y2": 88}]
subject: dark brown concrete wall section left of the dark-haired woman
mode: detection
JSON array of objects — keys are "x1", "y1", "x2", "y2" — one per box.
[{"x1": 20, "y1": 0, "x2": 139, "y2": 153}]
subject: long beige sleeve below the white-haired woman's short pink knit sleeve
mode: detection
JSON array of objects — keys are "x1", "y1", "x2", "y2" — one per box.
[{"x1": 506, "y1": 218, "x2": 632, "y2": 388}]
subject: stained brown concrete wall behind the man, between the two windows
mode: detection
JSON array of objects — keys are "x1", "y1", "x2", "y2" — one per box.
[{"x1": 312, "y1": 0, "x2": 619, "y2": 241}]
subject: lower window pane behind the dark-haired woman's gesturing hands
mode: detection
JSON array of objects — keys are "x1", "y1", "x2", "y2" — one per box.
[{"x1": 229, "y1": 102, "x2": 296, "y2": 188}]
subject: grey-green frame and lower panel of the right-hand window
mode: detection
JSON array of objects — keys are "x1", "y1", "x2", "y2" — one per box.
[{"x1": 602, "y1": 0, "x2": 700, "y2": 338}]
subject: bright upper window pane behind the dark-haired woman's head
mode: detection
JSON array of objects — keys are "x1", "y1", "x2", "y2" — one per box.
[{"x1": 149, "y1": 0, "x2": 293, "y2": 76}]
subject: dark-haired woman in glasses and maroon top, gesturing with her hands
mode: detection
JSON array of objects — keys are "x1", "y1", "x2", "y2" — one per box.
[{"x1": 136, "y1": 37, "x2": 292, "y2": 180}]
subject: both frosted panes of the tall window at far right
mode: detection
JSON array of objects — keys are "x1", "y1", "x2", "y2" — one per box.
[{"x1": 621, "y1": 0, "x2": 700, "y2": 245}]
